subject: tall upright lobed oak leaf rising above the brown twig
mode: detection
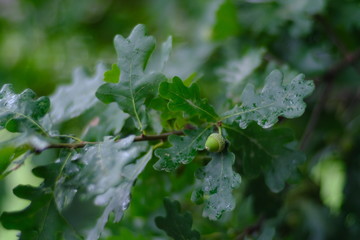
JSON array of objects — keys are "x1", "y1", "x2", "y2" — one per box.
[{"x1": 96, "y1": 25, "x2": 166, "y2": 131}]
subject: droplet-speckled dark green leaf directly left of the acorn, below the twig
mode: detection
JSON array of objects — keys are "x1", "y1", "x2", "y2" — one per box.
[{"x1": 154, "y1": 128, "x2": 212, "y2": 172}]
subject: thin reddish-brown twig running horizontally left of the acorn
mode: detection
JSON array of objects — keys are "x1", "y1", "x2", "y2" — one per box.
[{"x1": 35, "y1": 130, "x2": 184, "y2": 153}]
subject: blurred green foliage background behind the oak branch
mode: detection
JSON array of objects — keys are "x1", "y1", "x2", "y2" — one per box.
[{"x1": 0, "y1": 0, "x2": 360, "y2": 240}]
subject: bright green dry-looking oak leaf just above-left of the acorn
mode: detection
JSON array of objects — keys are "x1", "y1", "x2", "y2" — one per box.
[{"x1": 159, "y1": 77, "x2": 218, "y2": 122}]
